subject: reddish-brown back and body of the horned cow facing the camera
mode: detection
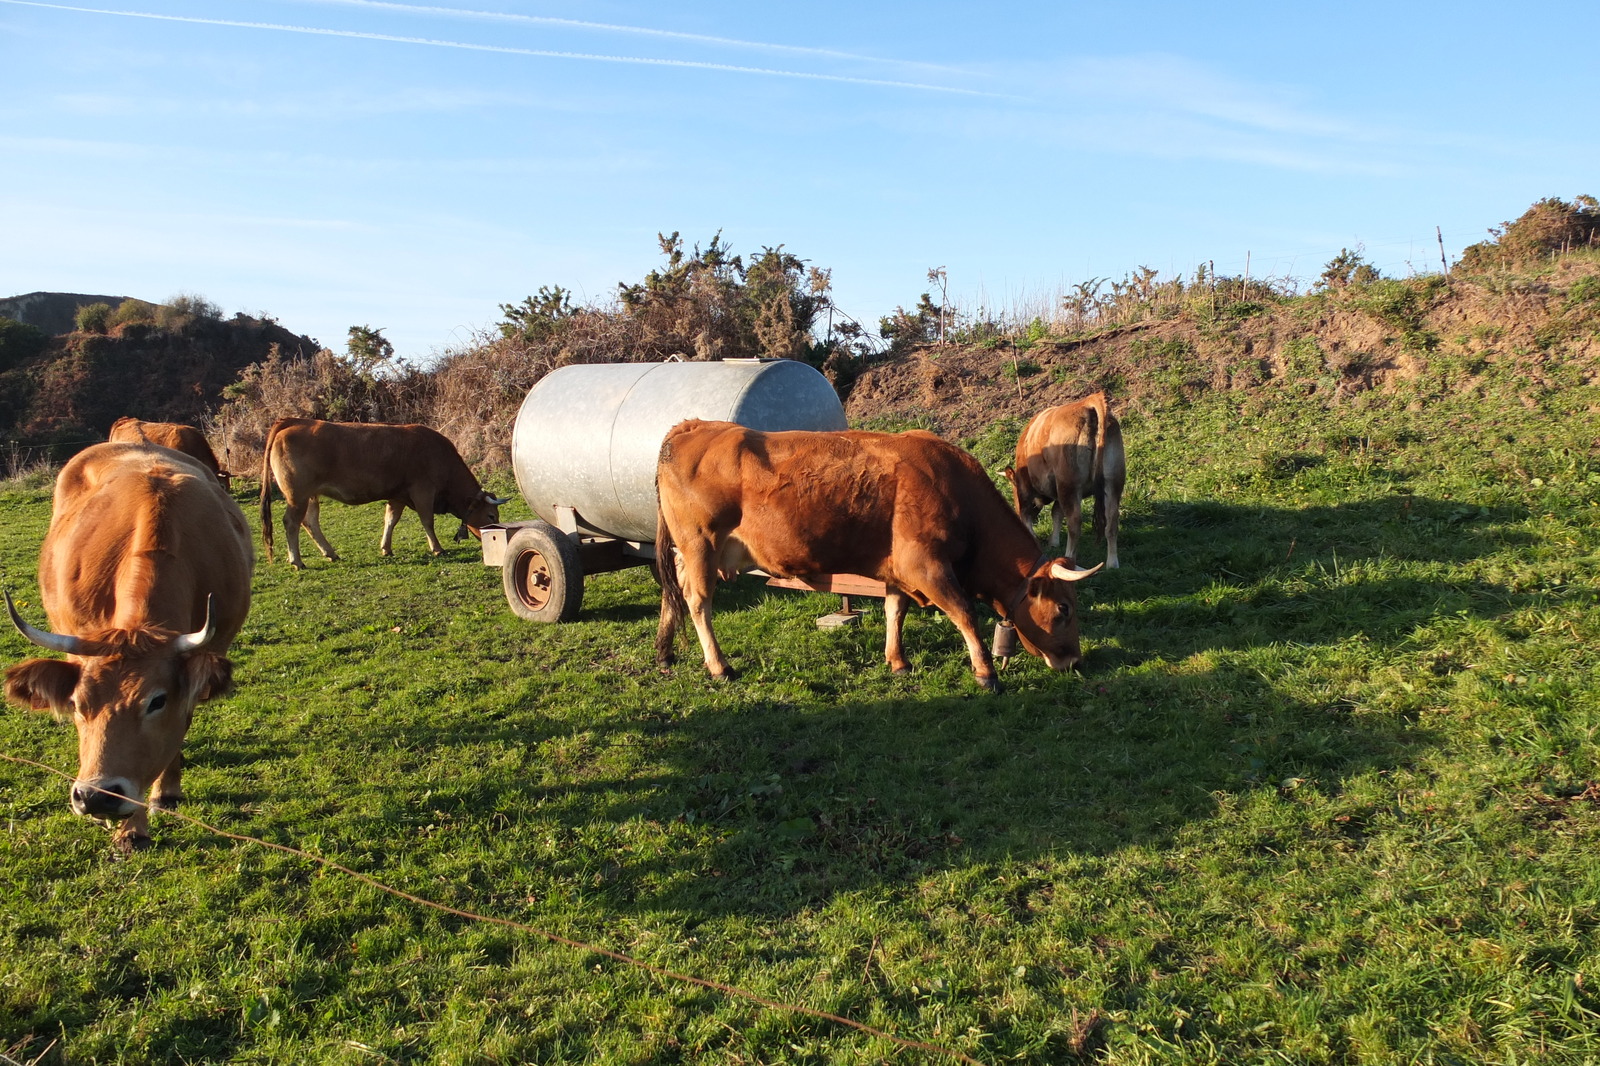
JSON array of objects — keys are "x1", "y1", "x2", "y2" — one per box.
[{"x1": 38, "y1": 442, "x2": 254, "y2": 650}]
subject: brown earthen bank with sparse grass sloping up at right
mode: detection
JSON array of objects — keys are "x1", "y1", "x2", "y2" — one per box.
[{"x1": 846, "y1": 251, "x2": 1600, "y2": 439}]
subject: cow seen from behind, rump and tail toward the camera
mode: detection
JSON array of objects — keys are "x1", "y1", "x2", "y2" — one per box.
[{"x1": 1005, "y1": 392, "x2": 1128, "y2": 570}]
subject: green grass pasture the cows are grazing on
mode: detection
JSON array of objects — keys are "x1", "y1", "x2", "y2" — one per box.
[{"x1": 0, "y1": 387, "x2": 1600, "y2": 1063}]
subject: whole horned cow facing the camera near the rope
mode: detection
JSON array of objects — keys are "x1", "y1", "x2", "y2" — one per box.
[{"x1": 5, "y1": 442, "x2": 254, "y2": 852}]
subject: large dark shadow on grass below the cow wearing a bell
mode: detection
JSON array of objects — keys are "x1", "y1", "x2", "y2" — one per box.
[{"x1": 508, "y1": 671, "x2": 1437, "y2": 917}]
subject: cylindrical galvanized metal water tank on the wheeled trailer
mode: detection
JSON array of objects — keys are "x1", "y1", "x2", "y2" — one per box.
[{"x1": 510, "y1": 359, "x2": 846, "y2": 541}]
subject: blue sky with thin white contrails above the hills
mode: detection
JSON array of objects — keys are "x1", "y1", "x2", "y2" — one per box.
[{"x1": 0, "y1": 0, "x2": 1600, "y2": 362}]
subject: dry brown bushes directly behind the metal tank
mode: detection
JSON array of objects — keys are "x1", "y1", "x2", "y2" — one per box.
[{"x1": 208, "y1": 234, "x2": 861, "y2": 472}]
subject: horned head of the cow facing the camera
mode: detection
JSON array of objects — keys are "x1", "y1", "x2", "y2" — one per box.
[{"x1": 5, "y1": 594, "x2": 234, "y2": 823}]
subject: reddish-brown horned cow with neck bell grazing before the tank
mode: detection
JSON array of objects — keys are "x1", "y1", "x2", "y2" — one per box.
[{"x1": 656, "y1": 421, "x2": 1099, "y2": 690}]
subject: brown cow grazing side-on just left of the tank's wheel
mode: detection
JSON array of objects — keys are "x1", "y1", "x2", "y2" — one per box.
[{"x1": 261, "y1": 418, "x2": 506, "y2": 570}]
